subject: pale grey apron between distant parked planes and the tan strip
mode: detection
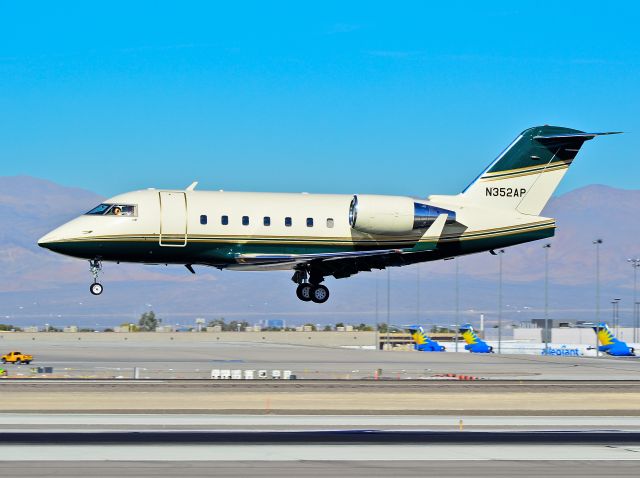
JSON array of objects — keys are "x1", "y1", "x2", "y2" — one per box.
[{"x1": 0, "y1": 333, "x2": 640, "y2": 380}]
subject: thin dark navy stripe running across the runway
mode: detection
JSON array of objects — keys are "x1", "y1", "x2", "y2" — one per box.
[{"x1": 0, "y1": 430, "x2": 640, "y2": 444}]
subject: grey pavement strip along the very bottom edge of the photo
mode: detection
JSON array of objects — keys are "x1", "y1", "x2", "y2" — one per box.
[{"x1": 5, "y1": 459, "x2": 638, "y2": 478}]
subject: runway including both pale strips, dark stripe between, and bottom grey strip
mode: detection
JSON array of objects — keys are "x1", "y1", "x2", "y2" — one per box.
[{"x1": 0, "y1": 414, "x2": 640, "y2": 478}]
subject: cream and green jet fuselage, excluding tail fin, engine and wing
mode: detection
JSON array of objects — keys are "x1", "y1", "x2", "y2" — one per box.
[{"x1": 40, "y1": 189, "x2": 554, "y2": 269}]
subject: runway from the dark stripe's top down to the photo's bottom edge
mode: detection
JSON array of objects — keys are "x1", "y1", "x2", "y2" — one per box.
[{"x1": 0, "y1": 431, "x2": 640, "y2": 477}]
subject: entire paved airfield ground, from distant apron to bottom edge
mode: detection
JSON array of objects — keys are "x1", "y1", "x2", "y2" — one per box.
[{"x1": 0, "y1": 334, "x2": 640, "y2": 478}]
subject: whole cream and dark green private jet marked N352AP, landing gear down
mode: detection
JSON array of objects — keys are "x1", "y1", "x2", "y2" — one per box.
[{"x1": 38, "y1": 125, "x2": 616, "y2": 303}]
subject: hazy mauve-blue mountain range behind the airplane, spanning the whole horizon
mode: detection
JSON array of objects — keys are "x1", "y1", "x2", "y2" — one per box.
[{"x1": 0, "y1": 176, "x2": 640, "y2": 326}]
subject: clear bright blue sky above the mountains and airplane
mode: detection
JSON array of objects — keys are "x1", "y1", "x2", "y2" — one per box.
[{"x1": 0, "y1": 0, "x2": 640, "y2": 196}]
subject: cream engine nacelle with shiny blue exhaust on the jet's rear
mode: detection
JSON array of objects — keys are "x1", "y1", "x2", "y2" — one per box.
[{"x1": 349, "y1": 194, "x2": 456, "y2": 235}]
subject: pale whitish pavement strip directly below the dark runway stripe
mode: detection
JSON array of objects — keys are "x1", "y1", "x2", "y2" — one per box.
[{"x1": 2, "y1": 443, "x2": 640, "y2": 461}]
